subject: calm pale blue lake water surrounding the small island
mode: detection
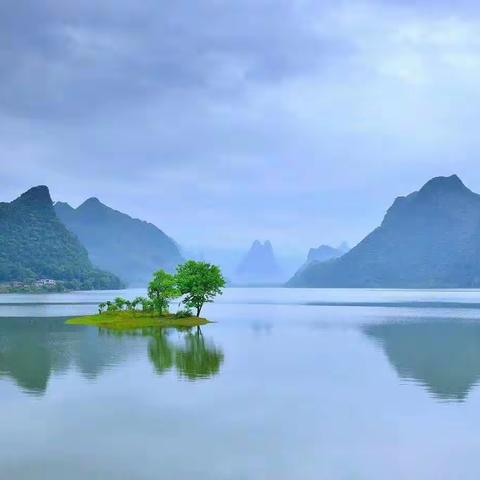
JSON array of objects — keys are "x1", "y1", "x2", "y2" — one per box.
[{"x1": 0, "y1": 289, "x2": 480, "y2": 480}]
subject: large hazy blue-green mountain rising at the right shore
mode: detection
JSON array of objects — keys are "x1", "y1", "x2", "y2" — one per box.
[{"x1": 287, "y1": 175, "x2": 480, "y2": 288}]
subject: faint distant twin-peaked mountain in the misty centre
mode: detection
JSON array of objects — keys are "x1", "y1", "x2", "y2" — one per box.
[{"x1": 235, "y1": 240, "x2": 282, "y2": 283}]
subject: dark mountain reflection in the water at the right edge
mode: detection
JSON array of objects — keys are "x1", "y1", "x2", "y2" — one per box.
[{"x1": 363, "y1": 319, "x2": 480, "y2": 401}]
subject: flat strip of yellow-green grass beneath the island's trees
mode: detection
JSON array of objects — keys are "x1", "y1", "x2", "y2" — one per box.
[{"x1": 65, "y1": 312, "x2": 210, "y2": 330}]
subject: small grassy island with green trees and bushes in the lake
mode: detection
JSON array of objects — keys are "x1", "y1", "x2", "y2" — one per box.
[{"x1": 66, "y1": 260, "x2": 225, "y2": 331}]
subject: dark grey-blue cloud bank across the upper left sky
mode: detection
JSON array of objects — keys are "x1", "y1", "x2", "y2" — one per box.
[{"x1": 0, "y1": 0, "x2": 344, "y2": 121}]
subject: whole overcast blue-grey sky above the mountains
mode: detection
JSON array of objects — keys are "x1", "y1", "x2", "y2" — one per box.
[{"x1": 0, "y1": 0, "x2": 480, "y2": 255}]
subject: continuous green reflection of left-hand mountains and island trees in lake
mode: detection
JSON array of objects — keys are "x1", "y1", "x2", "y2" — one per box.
[{"x1": 0, "y1": 317, "x2": 224, "y2": 395}]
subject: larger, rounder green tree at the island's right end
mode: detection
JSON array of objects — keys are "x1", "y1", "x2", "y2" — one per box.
[{"x1": 177, "y1": 260, "x2": 225, "y2": 317}]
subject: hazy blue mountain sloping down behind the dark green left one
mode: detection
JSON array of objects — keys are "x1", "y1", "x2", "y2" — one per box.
[{"x1": 55, "y1": 198, "x2": 183, "y2": 286}]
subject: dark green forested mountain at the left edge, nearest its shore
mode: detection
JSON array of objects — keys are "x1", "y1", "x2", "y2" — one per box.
[{"x1": 0, "y1": 185, "x2": 121, "y2": 289}]
